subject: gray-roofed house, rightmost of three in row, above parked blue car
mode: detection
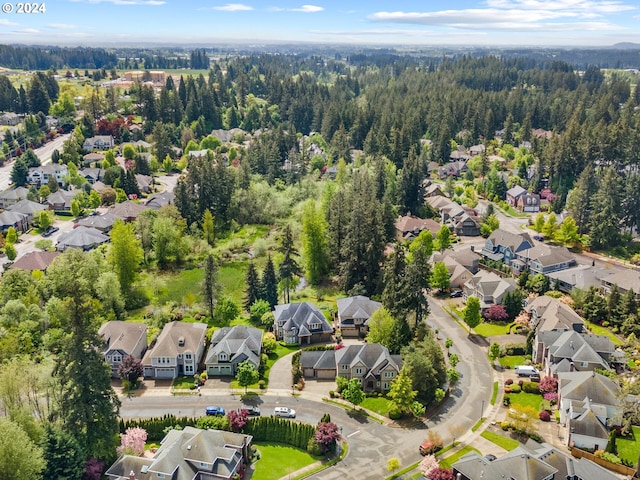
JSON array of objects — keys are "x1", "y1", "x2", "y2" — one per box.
[{"x1": 204, "y1": 325, "x2": 262, "y2": 376}]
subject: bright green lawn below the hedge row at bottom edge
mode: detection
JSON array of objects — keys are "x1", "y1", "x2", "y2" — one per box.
[{"x1": 251, "y1": 442, "x2": 320, "y2": 480}]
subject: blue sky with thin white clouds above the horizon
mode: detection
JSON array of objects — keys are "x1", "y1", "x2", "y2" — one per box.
[{"x1": 0, "y1": 0, "x2": 640, "y2": 46}]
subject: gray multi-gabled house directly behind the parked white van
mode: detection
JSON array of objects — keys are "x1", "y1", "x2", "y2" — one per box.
[{"x1": 532, "y1": 328, "x2": 615, "y2": 376}]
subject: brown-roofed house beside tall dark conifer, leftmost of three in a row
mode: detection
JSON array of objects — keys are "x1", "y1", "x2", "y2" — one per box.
[{"x1": 98, "y1": 320, "x2": 147, "y2": 377}]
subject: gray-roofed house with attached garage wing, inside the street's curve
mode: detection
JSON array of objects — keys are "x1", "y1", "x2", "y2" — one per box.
[{"x1": 300, "y1": 343, "x2": 402, "y2": 392}]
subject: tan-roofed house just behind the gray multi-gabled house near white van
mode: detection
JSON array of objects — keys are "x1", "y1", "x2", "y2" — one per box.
[{"x1": 524, "y1": 295, "x2": 584, "y2": 333}]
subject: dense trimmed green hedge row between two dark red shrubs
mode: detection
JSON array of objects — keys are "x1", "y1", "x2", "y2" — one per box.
[{"x1": 243, "y1": 417, "x2": 316, "y2": 450}]
